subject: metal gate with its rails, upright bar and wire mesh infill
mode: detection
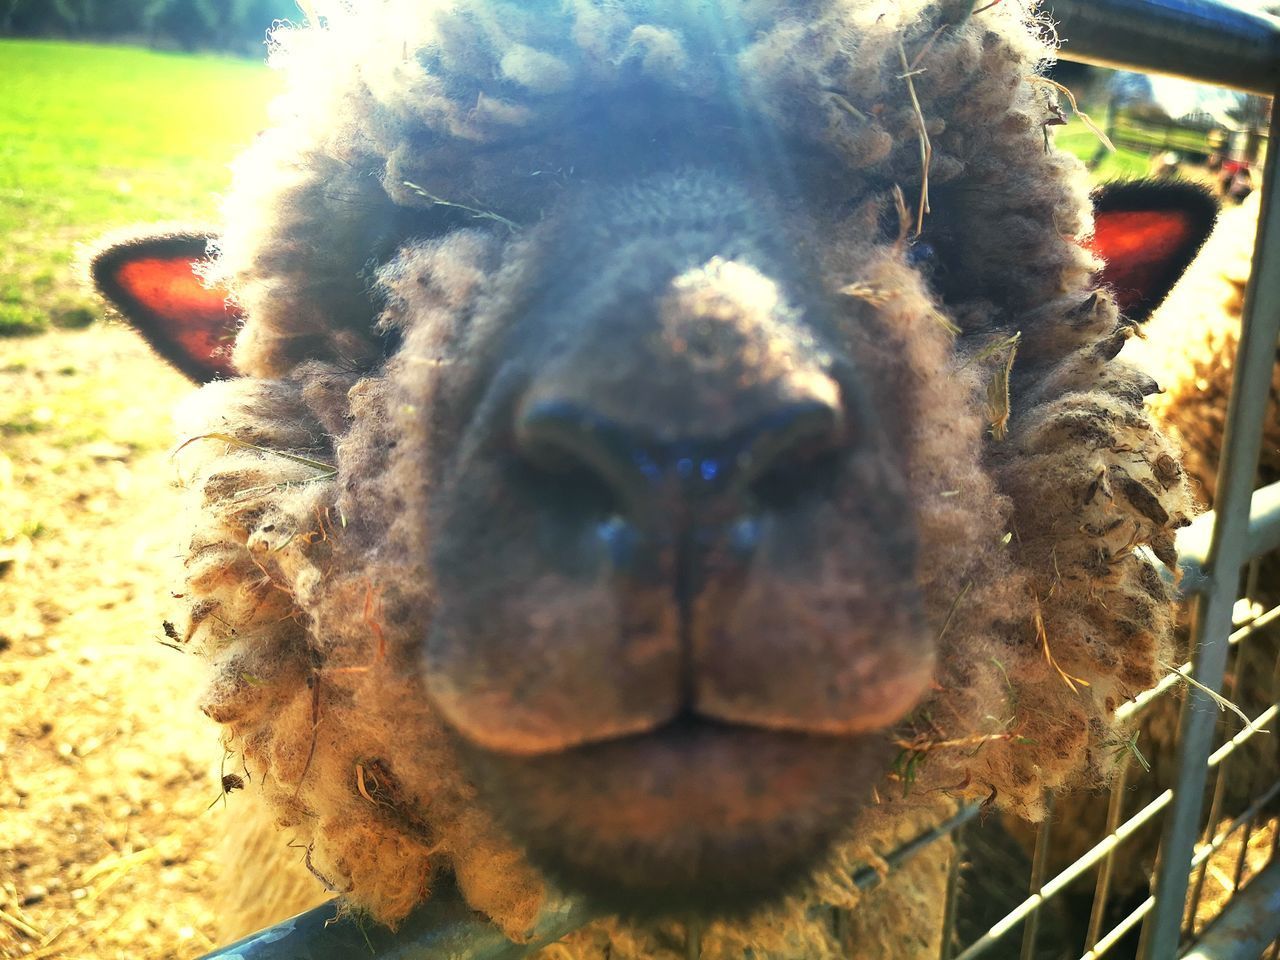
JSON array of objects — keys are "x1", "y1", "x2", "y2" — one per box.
[{"x1": 197, "y1": 0, "x2": 1280, "y2": 960}]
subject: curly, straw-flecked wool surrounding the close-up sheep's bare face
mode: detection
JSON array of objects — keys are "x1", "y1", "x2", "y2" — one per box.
[{"x1": 167, "y1": 0, "x2": 1188, "y2": 956}]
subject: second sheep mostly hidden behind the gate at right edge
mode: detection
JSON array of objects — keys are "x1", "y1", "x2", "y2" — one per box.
[{"x1": 1015, "y1": 195, "x2": 1280, "y2": 942}]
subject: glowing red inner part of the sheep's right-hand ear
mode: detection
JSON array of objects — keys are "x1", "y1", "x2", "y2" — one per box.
[{"x1": 1085, "y1": 210, "x2": 1192, "y2": 311}]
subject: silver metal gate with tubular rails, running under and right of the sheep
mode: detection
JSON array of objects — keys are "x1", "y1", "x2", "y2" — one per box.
[{"x1": 199, "y1": 0, "x2": 1280, "y2": 960}]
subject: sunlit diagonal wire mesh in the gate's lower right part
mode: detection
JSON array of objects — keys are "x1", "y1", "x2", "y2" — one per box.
[{"x1": 943, "y1": 506, "x2": 1280, "y2": 960}]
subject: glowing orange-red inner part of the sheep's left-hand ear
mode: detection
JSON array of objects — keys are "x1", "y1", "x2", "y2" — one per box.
[{"x1": 115, "y1": 257, "x2": 241, "y2": 376}]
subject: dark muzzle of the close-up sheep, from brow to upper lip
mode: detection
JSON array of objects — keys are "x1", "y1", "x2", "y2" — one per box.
[{"x1": 426, "y1": 170, "x2": 933, "y2": 755}]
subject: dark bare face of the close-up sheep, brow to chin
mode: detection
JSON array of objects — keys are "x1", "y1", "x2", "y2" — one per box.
[{"x1": 419, "y1": 169, "x2": 934, "y2": 905}]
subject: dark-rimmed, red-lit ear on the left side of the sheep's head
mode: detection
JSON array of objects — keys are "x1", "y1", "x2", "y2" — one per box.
[{"x1": 90, "y1": 233, "x2": 241, "y2": 383}]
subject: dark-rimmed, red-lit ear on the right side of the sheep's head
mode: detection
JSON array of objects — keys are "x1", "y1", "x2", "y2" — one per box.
[{"x1": 1087, "y1": 180, "x2": 1217, "y2": 323}]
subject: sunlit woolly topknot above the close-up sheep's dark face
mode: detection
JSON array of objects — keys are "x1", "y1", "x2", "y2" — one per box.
[{"x1": 216, "y1": 0, "x2": 1091, "y2": 374}]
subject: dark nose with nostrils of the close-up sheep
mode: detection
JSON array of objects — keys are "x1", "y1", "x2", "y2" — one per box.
[{"x1": 516, "y1": 397, "x2": 844, "y2": 534}]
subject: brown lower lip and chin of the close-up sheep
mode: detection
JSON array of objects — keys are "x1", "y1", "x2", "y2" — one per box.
[{"x1": 463, "y1": 717, "x2": 891, "y2": 918}]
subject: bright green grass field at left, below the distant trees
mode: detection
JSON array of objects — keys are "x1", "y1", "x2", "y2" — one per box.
[{"x1": 0, "y1": 40, "x2": 279, "y2": 335}]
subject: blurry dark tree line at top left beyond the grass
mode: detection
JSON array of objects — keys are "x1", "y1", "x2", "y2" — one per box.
[{"x1": 0, "y1": 0, "x2": 302, "y2": 54}]
